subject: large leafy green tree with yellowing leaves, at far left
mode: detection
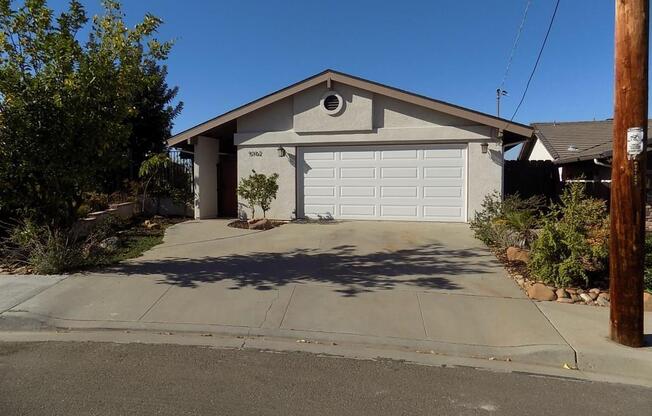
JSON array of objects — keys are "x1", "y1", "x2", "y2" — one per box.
[{"x1": 0, "y1": 0, "x2": 178, "y2": 225}]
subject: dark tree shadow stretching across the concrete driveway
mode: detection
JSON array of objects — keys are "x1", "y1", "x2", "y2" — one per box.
[{"x1": 106, "y1": 244, "x2": 504, "y2": 296}]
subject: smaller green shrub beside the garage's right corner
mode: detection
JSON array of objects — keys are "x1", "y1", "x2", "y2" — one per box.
[{"x1": 470, "y1": 192, "x2": 544, "y2": 249}]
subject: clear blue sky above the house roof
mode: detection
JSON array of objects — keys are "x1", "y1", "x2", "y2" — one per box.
[{"x1": 50, "y1": 0, "x2": 614, "y2": 141}]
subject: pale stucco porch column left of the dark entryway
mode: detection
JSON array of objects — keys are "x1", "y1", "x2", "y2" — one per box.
[{"x1": 194, "y1": 136, "x2": 220, "y2": 219}]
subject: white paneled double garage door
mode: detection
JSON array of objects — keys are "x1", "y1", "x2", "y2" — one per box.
[{"x1": 297, "y1": 145, "x2": 466, "y2": 222}]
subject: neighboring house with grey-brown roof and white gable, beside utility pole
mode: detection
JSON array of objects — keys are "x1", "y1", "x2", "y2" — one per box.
[{"x1": 518, "y1": 120, "x2": 650, "y2": 183}]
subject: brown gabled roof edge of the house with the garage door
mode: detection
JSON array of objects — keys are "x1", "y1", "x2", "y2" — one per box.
[{"x1": 168, "y1": 69, "x2": 532, "y2": 146}]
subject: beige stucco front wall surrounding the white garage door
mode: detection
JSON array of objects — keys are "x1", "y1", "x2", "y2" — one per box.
[{"x1": 234, "y1": 83, "x2": 503, "y2": 219}]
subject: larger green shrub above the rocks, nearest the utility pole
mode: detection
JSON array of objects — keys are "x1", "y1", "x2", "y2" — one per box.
[{"x1": 528, "y1": 182, "x2": 609, "y2": 287}]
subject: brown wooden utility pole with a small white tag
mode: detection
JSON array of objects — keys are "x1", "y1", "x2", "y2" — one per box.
[{"x1": 609, "y1": 0, "x2": 649, "y2": 347}]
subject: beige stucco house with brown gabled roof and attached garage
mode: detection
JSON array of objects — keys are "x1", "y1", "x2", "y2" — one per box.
[{"x1": 168, "y1": 70, "x2": 532, "y2": 222}]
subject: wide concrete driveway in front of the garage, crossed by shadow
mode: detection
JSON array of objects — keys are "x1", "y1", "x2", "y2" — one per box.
[{"x1": 0, "y1": 220, "x2": 652, "y2": 384}]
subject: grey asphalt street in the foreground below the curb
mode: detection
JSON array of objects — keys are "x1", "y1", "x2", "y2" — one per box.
[{"x1": 0, "y1": 342, "x2": 652, "y2": 416}]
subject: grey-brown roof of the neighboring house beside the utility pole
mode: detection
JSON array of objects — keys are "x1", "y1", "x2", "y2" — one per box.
[{"x1": 518, "y1": 119, "x2": 652, "y2": 164}]
